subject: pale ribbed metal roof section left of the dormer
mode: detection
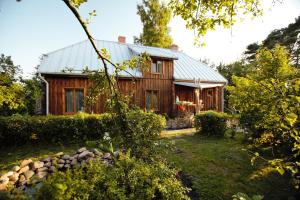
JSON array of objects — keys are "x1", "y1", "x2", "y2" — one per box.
[{"x1": 39, "y1": 40, "x2": 142, "y2": 77}]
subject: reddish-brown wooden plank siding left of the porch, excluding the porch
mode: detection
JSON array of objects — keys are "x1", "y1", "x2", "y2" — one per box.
[{"x1": 44, "y1": 60, "x2": 175, "y2": 115}]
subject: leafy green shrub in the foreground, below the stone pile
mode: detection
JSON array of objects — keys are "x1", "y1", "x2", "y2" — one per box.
[{"x1": 36, "y1": 154, "x2": 188, "y2": 200}]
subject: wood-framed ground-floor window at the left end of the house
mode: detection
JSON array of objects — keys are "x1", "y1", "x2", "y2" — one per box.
[{"x1": 65, "y1": 88, "x2": 84, "y2": 113}]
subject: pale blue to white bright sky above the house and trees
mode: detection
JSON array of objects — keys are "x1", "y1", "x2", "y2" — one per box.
[{"x1": 0, "y1": 0, "x2": 300, "y2": 77}]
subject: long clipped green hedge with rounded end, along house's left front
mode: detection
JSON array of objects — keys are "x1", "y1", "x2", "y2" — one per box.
[{"x1": 0, "y1": 110, "x2": 165, "y2": 147}]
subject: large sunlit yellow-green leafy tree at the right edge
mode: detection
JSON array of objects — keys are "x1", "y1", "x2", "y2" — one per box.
[{"x1": 228, "y1": 45, "x2": 300, "y2": 188}]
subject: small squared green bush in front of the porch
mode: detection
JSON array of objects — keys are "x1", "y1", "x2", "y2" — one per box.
[{"x1": 195, "y1": 111, "x2": 229, "y2": 137}]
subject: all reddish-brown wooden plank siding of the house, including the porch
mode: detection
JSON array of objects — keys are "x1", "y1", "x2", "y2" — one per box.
[{"x1": 43, "y1": 59, "x2": 223, "y2": 115}]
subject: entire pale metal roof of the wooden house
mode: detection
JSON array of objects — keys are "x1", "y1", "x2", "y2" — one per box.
[{"x1": 38, "y1": 40, "x2": 227, "y2": 83}]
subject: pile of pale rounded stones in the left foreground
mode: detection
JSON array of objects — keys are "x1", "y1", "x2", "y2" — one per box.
[{"x1": 0, "y1": 147, "x2": 112, "y2": 190}]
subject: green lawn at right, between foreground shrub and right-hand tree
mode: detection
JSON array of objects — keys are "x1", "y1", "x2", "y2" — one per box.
[{"x1": 159, "y1": 134, "x2": 295, "y2": 200}]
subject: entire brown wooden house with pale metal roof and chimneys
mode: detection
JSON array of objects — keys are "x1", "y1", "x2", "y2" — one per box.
[{"x1": 38, "y1": 37, "x2": 227, "y2": 115}]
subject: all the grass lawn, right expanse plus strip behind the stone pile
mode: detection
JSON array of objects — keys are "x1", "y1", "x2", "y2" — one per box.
[{"x1": 0, "y1": 129, "x2": 296, "y2": 200}]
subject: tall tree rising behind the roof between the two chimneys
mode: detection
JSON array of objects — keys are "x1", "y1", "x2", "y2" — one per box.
[{"x1": 134, "y1": 0, "x2": 172, "y2": 48}]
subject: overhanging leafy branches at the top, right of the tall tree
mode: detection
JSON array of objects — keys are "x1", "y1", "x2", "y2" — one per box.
[{"x1": 169, "y1": 0, "x2": 262, "y2": 44}]
